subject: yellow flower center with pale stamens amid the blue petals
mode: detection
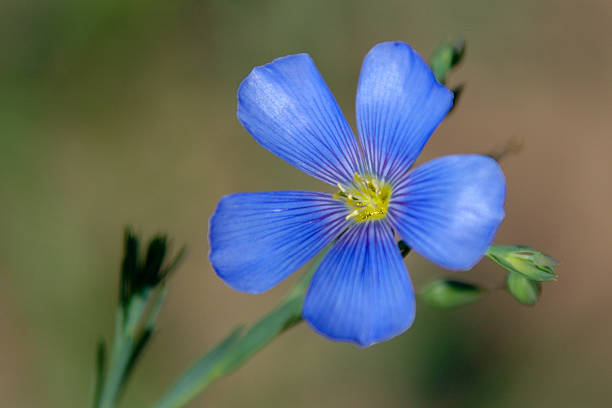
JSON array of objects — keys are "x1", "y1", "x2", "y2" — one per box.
[{"x1": 333, "y1": 173, "x2": 391, "y2": 222}]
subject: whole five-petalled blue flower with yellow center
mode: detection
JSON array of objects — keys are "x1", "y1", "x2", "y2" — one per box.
[{"x1": 209, "y1": 42, "x2": 506, "y2": 346}]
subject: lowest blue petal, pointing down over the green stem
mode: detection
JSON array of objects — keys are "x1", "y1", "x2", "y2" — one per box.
[{"x1": 303, "y1": 221, "x2": 415, "y2": 347}]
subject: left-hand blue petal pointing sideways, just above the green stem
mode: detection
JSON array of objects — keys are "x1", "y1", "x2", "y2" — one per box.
[{"x1": 209, "y1": 191, "x2": 348, "y2": 293}]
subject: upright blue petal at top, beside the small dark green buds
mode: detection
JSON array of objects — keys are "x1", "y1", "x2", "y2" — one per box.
[{"x1": 357, "y1": 42, "x2": 453, "y2": 182}]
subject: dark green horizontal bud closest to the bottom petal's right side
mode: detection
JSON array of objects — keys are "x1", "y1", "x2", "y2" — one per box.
[{"x1": 421, "y1": 280, "x2": 486, "y2": 309}]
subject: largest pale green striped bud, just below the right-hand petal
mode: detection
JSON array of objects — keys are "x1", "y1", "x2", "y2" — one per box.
[{"x1": 486, "y1": 245, "x2": 559, "y2": 282}]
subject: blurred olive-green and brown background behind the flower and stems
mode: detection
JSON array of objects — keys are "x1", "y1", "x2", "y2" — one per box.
[{"x1": 0, "y1": 0, "x2": 612, "y2": 408}]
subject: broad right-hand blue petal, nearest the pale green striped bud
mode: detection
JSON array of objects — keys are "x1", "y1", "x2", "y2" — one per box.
[{"x1": 389, "y1": 155, "x2": 506, "y2": 269}]
